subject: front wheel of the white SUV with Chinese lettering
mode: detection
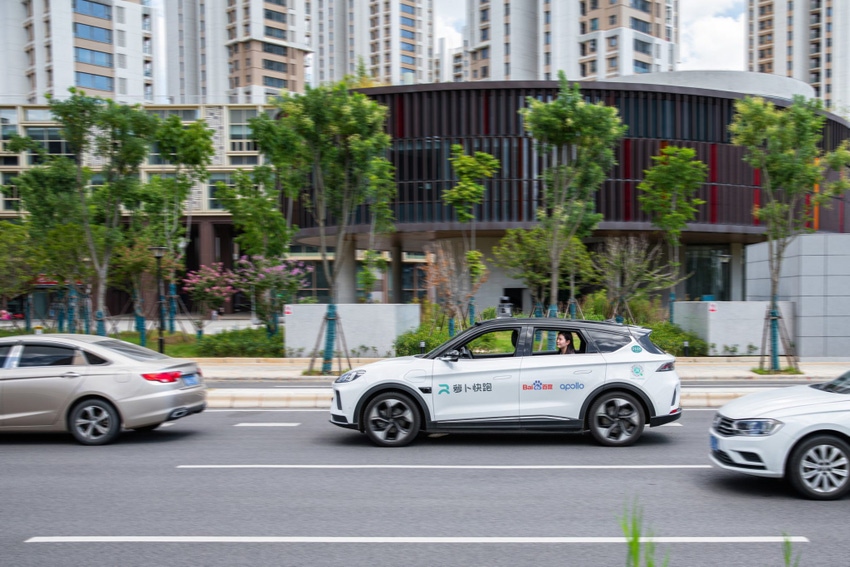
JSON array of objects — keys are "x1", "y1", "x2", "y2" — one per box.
[{"x1": 363, "y1": 392, "x2": 420, "y2": 447}]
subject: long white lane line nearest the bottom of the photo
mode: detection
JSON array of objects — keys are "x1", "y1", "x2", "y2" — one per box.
[{"x1": 25, "y1": 536, "x2": 809, "y2": 544}]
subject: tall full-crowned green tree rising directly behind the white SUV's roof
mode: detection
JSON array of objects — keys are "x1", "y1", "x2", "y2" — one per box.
[{"x1": 520, "y1": 71, "x2": 626, "y2": 316}]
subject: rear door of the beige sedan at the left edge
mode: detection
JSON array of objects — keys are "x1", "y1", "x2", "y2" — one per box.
[{"x1": 0, "y1": 341, "x2": 86, "y2": 427}]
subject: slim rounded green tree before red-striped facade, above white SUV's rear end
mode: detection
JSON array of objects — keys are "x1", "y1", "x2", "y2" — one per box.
[{"x1": 638, "y1": 146, "x2": 708, "y2": 316}]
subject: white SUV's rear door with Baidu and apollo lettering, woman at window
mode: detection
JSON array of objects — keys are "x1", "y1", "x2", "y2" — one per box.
[{"x1": 519, "y1": 325, "x2": 606, "y2": 429}]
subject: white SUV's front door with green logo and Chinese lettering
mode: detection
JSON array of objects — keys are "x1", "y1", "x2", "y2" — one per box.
[{"x1": 431, "y1": 326, "x2": 522, "y2": 429}]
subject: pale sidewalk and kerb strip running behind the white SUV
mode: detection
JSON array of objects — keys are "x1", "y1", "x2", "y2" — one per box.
[{"x1": 196, "y1": 357, "x2": 850, "y2": 408}]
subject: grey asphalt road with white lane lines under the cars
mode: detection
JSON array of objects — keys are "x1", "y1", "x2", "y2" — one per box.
[{"x1": 0, "y1": 410, "x2": 850, "y2": 567}]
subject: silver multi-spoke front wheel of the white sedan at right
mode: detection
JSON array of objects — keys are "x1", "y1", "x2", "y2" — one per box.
[{"x1": 787, "y1": 435, "x2": 850, "y2": 500}]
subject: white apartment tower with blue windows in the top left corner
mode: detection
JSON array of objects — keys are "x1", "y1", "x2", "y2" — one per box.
[{"x1": 0, "y1": 0, "x2": 165, "y2": 103}]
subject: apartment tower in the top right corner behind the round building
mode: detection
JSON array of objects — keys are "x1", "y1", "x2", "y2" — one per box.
[{"x1": 745, "y1": 0, "x2": 850, "y2": 115}]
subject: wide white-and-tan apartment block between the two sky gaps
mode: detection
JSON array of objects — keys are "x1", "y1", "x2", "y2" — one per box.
[{"x1": 465, "y1": 0, "x2": 679, "y2": 81}]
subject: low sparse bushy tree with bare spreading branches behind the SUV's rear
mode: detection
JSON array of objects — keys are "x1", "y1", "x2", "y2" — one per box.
[{"x1": 594, "y1": 236, "x2": 679, "y2": 319}]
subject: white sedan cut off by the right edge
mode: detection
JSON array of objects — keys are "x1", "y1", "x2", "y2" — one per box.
[{"x1": 709, "y1": 372, "x2": 850, "y2": 500}]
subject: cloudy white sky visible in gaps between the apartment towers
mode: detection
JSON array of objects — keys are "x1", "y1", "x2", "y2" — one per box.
[{"x1": 434, "y1": 0, "x2": 744, "y2": 71}]
